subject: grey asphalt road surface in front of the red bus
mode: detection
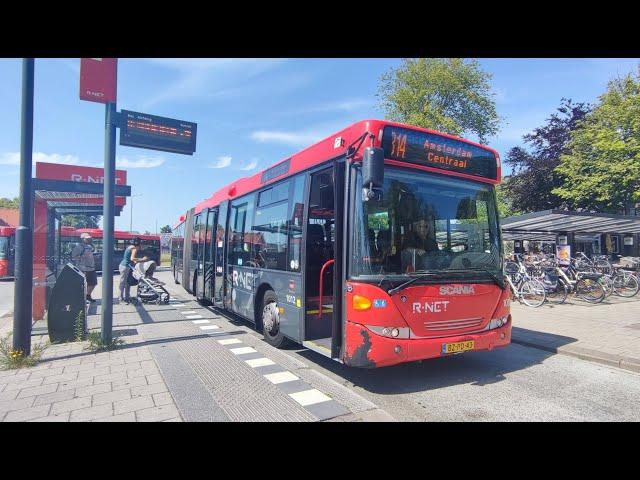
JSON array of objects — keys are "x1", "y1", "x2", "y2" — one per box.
[{"x1": 292, "y1": 344, "x2": 640, "y2": 421}]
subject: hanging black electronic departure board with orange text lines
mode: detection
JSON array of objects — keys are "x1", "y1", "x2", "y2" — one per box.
[{"x1": 120, "y1": 110, "x2": 197, "y2": 155}]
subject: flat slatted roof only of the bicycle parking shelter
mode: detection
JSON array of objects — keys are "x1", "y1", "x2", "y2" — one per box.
[{"x1": 501, "y1": 210, "x2": 640, "y2": 241}]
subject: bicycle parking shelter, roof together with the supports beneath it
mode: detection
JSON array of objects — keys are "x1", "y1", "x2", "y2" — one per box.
[{"x1": 501, "y1": 210, "x2": 640, "y2": 257}]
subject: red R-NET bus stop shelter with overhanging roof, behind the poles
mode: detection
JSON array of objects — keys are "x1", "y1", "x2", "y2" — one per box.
[{"x1": 32, "y1": 162, "x2": 131, "y2": 320}]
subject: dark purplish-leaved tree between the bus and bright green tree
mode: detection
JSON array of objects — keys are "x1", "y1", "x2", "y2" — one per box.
[{"x1": 503, "y1": 98, "x2": 590, "y2": 212}]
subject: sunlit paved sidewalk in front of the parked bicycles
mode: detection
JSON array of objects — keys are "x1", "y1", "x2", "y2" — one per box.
[{"x1": 512, "y1": 296, "x2": 640, "y2": 372}]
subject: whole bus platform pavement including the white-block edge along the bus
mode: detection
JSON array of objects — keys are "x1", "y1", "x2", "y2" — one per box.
[{"x1": 0, "y1": 272, "x2": 393, "y2": 422}]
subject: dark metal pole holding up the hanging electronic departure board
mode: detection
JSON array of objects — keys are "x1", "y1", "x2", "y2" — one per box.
[{"x1": 101, "y1": 102, "x2": 116, "y2": 344}]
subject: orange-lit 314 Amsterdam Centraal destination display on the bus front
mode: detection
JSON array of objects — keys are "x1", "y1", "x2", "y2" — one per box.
[{"x1": 382, "y1": 127, "x2": 498, "y2": 180}]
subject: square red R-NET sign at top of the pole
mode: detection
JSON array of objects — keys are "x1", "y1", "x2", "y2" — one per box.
[{"x1": 80, "y1": 58, "x2": 118, "y2": 103}]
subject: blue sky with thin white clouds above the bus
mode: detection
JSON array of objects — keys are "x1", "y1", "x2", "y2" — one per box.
[{"x1": 0, "y1": 58, "x2": 640, "y2": 232}]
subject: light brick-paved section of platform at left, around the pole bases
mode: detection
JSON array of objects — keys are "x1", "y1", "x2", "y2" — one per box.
[{"x1": 0, "y1": 305, "x2": 181, "y2": 422}]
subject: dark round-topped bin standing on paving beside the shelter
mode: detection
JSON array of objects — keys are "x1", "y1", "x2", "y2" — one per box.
[{"x1": 47, "y1": 263, "x2": 87, "y2": 343}]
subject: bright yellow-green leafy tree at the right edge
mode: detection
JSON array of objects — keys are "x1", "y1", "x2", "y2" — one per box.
[{"x1": 553, "y1": 67, "x2": 640, "y2": 213}]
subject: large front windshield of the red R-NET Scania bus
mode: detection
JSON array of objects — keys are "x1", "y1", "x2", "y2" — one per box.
[{"x1": 350, "y1": 167, "x2": 502, "y2": 277}]
